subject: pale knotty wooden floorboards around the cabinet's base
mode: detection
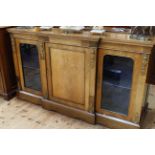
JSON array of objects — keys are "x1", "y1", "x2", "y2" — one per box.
[{"x1": 0, "y1": 97, "x2": 155, "y2": 129}]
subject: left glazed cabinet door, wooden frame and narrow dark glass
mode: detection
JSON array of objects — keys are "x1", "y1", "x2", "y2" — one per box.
[{"x1": 16, "y1": 39, "x2": 47, "y2": 97}]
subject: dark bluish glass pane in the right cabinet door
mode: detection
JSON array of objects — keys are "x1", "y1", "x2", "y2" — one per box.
[{"x1": 101, "y1": 55, "x2": 133, "y2": 115}]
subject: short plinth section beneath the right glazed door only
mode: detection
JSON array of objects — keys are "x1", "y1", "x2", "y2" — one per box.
[{"x1": 96, "y1": 113, "x2": 140, "y2": 129}]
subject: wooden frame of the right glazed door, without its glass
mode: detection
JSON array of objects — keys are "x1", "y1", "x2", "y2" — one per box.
[{"x1": 95, "y1": 49, "x2": 141, "y2": 121}]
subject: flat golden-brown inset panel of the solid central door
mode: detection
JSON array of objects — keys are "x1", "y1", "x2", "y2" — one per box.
[{"x1": 50, "y1": 49, "x2": 85, "y2": 104}]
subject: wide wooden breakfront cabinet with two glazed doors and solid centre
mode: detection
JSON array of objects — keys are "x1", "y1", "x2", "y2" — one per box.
[{"x1": 8, "y1": 28, "x2": 152, "y2": 128}]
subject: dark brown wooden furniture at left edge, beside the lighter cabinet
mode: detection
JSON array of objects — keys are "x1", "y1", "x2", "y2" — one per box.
[{"x1": 0, "y1": 27, "x2": 16, "y2": 100}]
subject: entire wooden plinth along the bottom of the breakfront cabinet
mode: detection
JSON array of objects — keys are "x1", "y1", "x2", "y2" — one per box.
[{"x1": 17, "y1": 91, "x2": 140, "y2": 129}]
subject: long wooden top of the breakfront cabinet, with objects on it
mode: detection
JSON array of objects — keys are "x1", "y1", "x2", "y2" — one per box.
[{"x1": 8, "y1": 28, "x2": 154, "y2": 47}]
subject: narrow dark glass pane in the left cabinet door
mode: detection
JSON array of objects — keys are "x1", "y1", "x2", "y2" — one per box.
[{"x1": 20, "y1": 44, "x2": 41, "y2": 91}]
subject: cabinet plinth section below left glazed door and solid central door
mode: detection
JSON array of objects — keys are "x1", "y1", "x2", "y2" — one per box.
[{"x1": 17, "y1": 91, "x2": 95, "y2": 124}]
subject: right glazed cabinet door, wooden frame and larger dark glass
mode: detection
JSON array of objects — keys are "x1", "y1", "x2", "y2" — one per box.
[{"x1": 96, "y1": 49, "x2": 141, "y2": 121}]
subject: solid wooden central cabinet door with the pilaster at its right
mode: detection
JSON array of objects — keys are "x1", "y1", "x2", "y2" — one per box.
[{"x1": 46, "y1": 43, "x2": 96, "y2": 111}]
